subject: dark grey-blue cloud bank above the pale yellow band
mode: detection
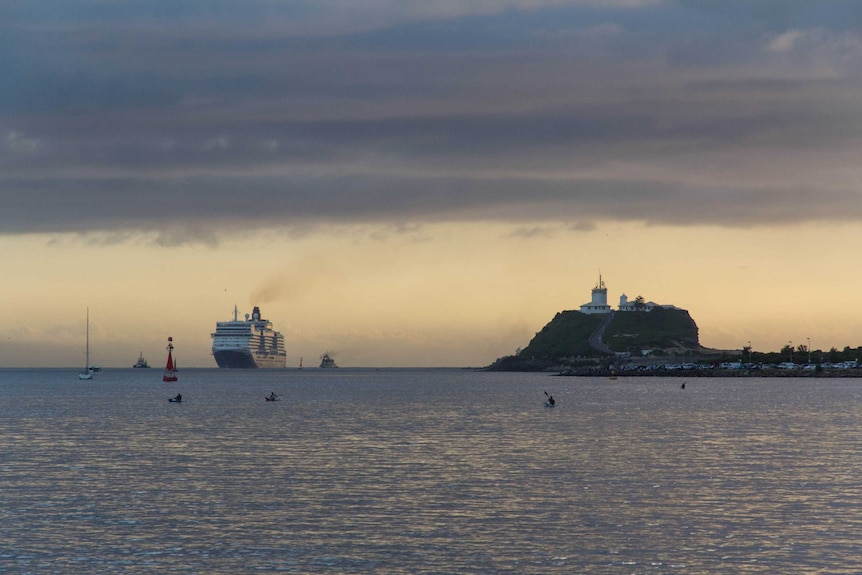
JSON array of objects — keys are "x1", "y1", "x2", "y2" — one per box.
[{"x1": 0, "y1": 0, "x2": 862, "y2": 237}]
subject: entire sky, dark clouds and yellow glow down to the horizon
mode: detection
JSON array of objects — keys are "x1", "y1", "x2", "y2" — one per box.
[{"x1": 5, "y1": 0, "x2": 862, "y2": 367}]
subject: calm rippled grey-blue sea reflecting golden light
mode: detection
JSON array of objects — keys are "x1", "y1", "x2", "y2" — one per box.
[{"x1": 5, "y1": 369, "x2": 862, "y2": 575}]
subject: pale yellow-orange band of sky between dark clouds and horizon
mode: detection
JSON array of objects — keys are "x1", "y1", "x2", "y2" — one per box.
[{"x1": 5, "y1": 223, "x2": 860, "y2": 367}]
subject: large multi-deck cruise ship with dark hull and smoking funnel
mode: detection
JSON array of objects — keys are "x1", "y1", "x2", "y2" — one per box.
[{"x1": 212, "y1": 306, "x2": 287, "y2": 369}]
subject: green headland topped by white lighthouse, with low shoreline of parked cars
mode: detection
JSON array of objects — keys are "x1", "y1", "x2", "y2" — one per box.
[{"x1": 485, "y1": 276, "x2": 862, "y2": 377}]
